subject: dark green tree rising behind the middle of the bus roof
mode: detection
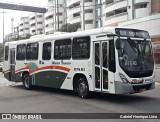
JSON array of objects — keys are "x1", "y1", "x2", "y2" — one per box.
[{"x1": 60, "y1": 23, "x2": 81, "y2": 32}]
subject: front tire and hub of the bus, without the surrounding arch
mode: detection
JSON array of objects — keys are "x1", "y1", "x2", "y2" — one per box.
[{"x1": 77, "y1": 77, "x2": 90, "y2": 98}]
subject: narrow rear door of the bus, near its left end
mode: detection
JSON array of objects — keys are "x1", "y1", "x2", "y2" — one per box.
[{"x1": 9, "y1": 49, "x2": 15, "y2": 81}]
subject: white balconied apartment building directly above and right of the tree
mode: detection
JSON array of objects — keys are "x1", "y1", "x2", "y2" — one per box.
[{"x1": 67, "y1": 0, "x2": 96, "y2": 30}]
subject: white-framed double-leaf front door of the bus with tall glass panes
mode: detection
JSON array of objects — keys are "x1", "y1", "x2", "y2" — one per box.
[{"x1": 93, "y1": 41, "x2": 108, "y2": 91}]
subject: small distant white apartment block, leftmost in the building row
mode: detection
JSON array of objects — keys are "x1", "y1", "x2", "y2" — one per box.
[{"x1": 19, "y1": 16, "x2": 30, "y2": 37}]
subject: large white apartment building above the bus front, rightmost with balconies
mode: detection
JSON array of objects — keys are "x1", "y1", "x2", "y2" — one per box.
[{"x1": 102, "y1": 0, "x2": 151, "y2": 26}]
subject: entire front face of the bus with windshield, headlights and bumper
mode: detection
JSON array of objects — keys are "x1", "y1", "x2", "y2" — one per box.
[{"x1": 115, "y1": 28, "x2": 155, "y2": 94}]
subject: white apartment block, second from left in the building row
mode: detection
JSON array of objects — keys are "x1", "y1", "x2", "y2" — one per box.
[{"x1": 29, "y1": 13, "x2": 45, "y2": 35}]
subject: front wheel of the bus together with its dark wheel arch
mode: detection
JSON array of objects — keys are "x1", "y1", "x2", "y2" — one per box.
[{"x1": 73, "y1": 73, "x2": 90, "y2": 98}]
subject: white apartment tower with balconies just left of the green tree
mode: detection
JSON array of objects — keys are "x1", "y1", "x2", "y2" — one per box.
[{"x1": 45, "y1": 0, "x2": 66, "y2": 34}]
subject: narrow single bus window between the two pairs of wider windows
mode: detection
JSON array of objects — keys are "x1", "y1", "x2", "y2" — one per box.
[{"x1": 42, "y1": 42, "x2": 51, "y2": 60}]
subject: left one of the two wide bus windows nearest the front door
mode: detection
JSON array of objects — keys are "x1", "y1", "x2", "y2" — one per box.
[{"x1": 54, "y1": 39, "x2": 71, "y2": 60}]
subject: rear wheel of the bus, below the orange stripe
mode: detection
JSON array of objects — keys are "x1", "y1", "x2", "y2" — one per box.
[{"x1": 23, "y1": 74, "x2": 32, "y2": 90}]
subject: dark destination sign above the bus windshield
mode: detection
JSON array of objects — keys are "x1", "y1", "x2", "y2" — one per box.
[{"x1": 116, "y1": 28, "x2": 150, "y2": 39}]
